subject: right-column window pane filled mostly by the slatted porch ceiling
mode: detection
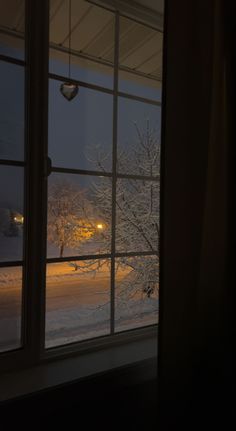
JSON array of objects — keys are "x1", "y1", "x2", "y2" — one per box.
[{"x1": 119, "y1": 17, "x2": 163, "y2": 100}]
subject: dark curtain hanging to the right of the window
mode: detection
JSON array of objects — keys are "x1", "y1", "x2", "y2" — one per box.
[{"x1": 158, "y1": 0, "x2": 236, "y2": 430}]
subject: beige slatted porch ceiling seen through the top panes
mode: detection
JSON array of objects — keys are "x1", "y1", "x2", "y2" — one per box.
[{"x1": 0, "y1": 0, "x2": 163, "y2": 81}]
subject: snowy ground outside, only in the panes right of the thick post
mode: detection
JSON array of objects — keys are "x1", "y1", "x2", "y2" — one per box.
[{"x1": 46, "y1": 264, "x2": 157, "y2": 347}]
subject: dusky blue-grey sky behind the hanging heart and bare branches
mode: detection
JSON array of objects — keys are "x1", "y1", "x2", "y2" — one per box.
[{"x1": 0, "y1": 41, "x2": 161, "y2": 211}]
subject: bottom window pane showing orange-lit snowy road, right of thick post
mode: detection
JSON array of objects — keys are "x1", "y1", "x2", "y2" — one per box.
[{"x1": 46, "y1": 260, "x2": 110, "y2": 348}]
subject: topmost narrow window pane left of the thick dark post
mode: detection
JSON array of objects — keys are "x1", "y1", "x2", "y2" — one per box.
[{"x1": 0, "y1": 0, "x2": 25, "y2": 59}]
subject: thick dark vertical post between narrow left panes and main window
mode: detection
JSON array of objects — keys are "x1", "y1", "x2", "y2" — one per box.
[{"x1": 24, "y1": 0, "x2": 49, "y2": 362}]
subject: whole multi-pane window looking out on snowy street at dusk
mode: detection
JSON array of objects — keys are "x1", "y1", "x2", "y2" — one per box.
[{"x1": 0, "y1": 0, "x2": 162, "y2": 368}]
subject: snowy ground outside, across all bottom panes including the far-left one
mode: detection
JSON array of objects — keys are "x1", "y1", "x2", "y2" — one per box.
[{"x1": 0, "y1": 238, "x2": 158, "y2": 351}]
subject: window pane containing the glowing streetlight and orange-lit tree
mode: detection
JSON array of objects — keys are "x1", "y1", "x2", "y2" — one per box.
[{"x1": 47, "y1": 173, "x2": 111, "y2": 257}]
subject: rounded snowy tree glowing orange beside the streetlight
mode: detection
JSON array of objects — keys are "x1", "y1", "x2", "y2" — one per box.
[{"x1": 48, "y1": 179, "x2": 94, "y2": 257}]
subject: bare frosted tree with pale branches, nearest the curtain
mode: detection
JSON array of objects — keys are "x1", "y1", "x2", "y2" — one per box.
[{"x1": 90, "y1": 120, "x2": 160, "y2": 297}]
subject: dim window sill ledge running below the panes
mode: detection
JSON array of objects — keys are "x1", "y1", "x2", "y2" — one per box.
[{"x1": 0, "y1": 335, "x2": 157, "y2": 402}]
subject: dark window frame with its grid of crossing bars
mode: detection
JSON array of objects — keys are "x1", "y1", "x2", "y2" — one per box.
[{"x1": 0, "y1": 0, "x2": 161, "y2": 370}]
